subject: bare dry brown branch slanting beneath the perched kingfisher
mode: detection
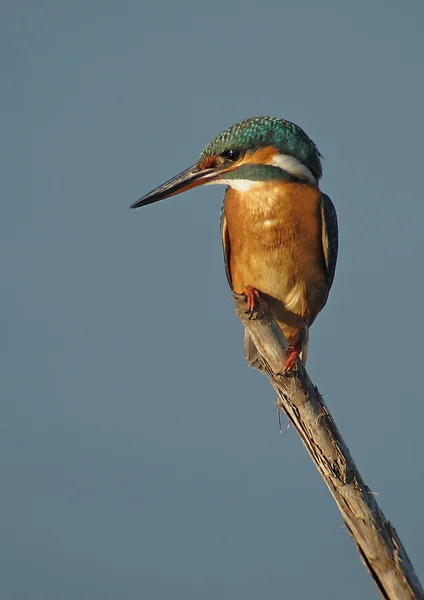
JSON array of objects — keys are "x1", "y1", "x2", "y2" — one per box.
[{"x1": 234, "y1": 295, "x2": 424, "y2": 600}]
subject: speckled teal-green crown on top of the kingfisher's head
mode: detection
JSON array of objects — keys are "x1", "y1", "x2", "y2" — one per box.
[{"x1": 200, "y1": 117, "x2": 322, "y2": 180}]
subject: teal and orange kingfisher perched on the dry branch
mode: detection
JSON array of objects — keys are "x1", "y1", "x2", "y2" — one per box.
[{"x1": 131, "y1": 117, "x2": 338, "y2": 373}]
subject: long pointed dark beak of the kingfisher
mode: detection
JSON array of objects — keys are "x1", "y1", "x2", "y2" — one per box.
[{"x1": 130, "y1": 164, "x2": 220, "y2": 208}]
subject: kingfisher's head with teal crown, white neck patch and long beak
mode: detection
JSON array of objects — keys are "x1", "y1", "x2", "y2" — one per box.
[{"x1": 131, "y1": 117, "x2": 322, "y2": 208}]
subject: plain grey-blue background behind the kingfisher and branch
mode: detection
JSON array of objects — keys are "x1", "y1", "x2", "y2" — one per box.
[{"x1": 0, "y1": 0, "x2": 424, "y2": 600}]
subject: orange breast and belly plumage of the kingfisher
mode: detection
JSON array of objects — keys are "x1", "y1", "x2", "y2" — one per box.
[{"x1": 224, "y1": 182, "x2": 328, "y2": 341}]
